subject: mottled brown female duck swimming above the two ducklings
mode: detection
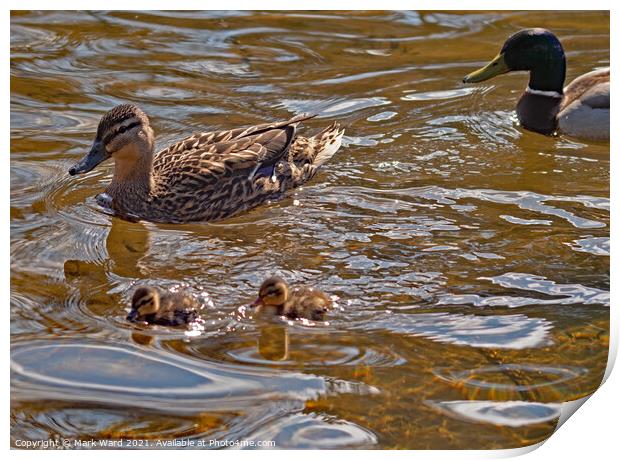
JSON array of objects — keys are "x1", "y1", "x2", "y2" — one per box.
[{"x1": 69, "y1": 104, "x2": 344, "y2": 223}]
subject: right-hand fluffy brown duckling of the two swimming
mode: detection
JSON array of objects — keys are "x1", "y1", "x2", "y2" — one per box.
[{"x1": 251, "y1": 276, "x2": 332, "y2": 321}]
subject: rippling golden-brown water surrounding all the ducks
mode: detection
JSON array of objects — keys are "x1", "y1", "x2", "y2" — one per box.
[{"x1": 11, "y1": 12, "x2": 609, "y2": 449}]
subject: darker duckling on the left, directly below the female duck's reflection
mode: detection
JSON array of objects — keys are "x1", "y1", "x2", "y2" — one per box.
[{"x1": 127, "y1": 286, "x2": 200, "y2": 326}]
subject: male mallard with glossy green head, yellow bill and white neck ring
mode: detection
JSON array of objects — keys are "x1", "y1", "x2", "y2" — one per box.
[{"x1": 463, "y1": 29, "x2": 609, "y2": 140}]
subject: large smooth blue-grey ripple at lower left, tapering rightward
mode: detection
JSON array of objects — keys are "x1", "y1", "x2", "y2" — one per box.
[{"x1": 11, "y1": 342, "x2": 372, "y2": 414}]
